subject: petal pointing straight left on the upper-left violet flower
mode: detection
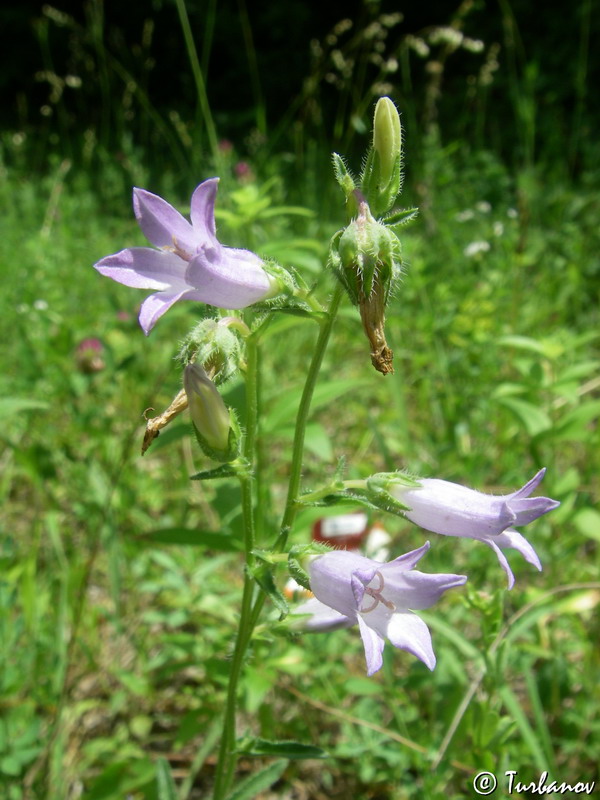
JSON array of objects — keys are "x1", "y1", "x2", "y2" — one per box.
[{"x1": 94, "y1": 247, "x2": 191, "y2": 291}]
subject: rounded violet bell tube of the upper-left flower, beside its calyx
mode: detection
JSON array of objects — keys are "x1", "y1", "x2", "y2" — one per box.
[{"x1": 186, "y1": 247, "x2": 271, "y2": 308}]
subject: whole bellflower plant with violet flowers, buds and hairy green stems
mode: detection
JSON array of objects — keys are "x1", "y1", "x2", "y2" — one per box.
[{"x1": 94, "y1": 97, "x2": 558, "y2": 800}]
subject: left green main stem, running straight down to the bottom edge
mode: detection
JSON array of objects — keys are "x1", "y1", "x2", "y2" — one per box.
[{"x1": 213, "y1": 335, "x2": 258, "y2": 800}]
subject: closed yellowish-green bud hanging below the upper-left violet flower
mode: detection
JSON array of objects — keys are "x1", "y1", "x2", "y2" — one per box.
[{"x1": 183, "y1": 364, "x2": 237, "y2": 461}]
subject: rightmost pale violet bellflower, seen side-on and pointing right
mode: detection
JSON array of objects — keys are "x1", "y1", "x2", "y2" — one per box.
[{"x1": 387, "y1": 469, "x2": 560, "y2": 589}]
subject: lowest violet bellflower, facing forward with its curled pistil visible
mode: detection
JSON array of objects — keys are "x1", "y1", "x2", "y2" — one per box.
[{"x1": 296, "y1": 542, "x2": 467, "y2": 675}]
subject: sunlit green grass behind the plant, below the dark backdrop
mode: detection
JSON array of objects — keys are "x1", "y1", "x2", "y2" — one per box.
[{"x1": 0, "y1": 139, "x2": 600, "y2": 800}]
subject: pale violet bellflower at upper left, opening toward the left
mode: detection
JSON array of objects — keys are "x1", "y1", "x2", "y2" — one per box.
[{"x1": 94, "y1": 178, "x2": 280, "y2": 335}]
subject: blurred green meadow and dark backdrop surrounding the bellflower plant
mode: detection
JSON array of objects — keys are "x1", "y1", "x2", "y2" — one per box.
[{"x1": 0, "y1": 0, "x2": 600, "y2": 800}]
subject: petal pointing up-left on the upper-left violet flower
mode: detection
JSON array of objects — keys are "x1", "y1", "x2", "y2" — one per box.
[{"x1": 133, "y1": 188, "x2": 200, "y2": 255}]
